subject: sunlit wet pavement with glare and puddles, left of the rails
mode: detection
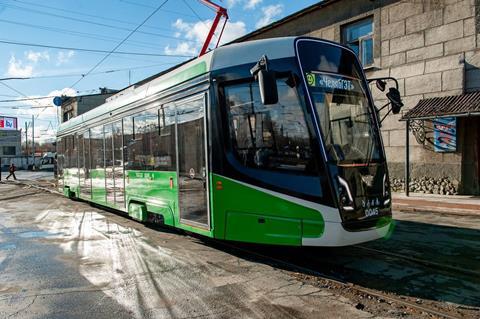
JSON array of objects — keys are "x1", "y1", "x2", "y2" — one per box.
[{"x1": 0, "y1": 184, "x2": 386, "y2": 318}]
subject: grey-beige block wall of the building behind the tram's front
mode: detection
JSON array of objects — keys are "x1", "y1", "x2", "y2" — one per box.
[{"x1": 242, "y1": 0, "x2": 480, "y2": 192}]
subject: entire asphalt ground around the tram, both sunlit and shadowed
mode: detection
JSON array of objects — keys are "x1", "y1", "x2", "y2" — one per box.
[{"x1": 0, "y1": 174, "x2": 480, "y2": 318}]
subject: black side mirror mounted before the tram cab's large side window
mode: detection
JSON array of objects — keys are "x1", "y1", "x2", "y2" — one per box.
[{"x1": 250, "y1": 55, "x2": 278, "y2": 105}]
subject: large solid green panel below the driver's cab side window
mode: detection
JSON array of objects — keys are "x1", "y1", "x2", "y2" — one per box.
[{"x1": 212, "y1": 175, "x2": 325, "y2": 246}]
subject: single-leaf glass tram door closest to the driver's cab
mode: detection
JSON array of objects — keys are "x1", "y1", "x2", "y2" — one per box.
[{"x1": 176, "y1": 96, "x2": 210, "y2": 228}]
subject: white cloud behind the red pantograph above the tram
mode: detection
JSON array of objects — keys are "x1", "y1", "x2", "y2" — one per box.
[{"x1": 165, "y1": 19, "x2": 247, "y2": 55}]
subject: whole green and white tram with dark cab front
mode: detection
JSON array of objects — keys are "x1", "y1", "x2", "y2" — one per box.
[{"x1": 57, "y1": 37, "x2": 402, "y2": 246}]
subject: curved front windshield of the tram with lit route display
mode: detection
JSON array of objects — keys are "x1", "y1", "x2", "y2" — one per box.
[{"x1": 298, "y1": 40, "x2": 382, "y2": 165}]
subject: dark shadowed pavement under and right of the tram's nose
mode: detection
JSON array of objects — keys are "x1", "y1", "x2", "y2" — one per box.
[{"x1": 244, "y1": 212, "x2": 480, "y2": 318}]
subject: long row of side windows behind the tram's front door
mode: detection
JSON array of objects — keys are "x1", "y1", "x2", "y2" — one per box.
[{"x1": 57, "y1": 105, "x2": 176, "y2": 176}]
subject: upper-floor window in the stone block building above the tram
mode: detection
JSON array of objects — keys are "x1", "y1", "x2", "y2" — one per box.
[{"x1": 342, "y1": 17, "x2": 373, "y2": 67}]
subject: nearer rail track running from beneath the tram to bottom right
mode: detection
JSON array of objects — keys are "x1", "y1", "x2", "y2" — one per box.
[{"x1": 213, "y1": 240, "x2": 477, "y2": 319}]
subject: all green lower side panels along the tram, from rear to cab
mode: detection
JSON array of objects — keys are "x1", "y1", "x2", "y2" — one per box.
[{"x1": 60, "y1": 169, "x2": 325, "y2": 246}]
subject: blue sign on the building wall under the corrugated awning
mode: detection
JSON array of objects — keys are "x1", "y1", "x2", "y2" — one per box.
[{"x1": 433, "y1": 117, "x2": 457, "y2": 153}]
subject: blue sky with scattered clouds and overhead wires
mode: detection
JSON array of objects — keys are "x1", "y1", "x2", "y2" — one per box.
[{"x1": 0, "y1": 0, "x2": 319, "y2": 142}]
